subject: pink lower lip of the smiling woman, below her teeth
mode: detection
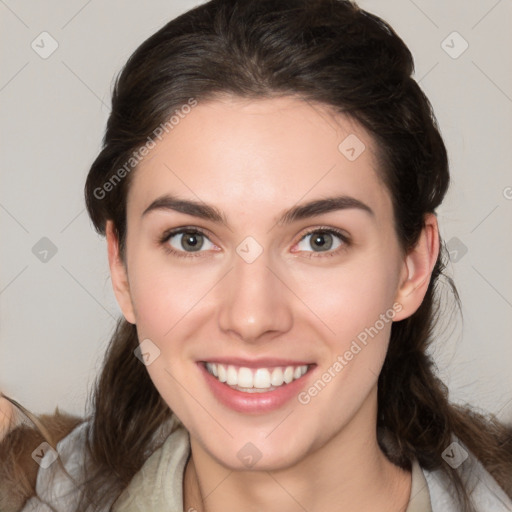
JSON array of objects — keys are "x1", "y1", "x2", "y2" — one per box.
[{"x1": 197, "y1": 362, "x2": 314, "y2": 413}]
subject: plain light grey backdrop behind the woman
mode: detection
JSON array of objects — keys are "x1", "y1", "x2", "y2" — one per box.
[{"x1": 0, "y1": 0, "x2": 512, "y2": 421}]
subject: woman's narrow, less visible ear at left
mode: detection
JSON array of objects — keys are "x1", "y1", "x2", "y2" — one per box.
[{"x1": 106, "y1": 220, "x2": 136, "y2": 324}]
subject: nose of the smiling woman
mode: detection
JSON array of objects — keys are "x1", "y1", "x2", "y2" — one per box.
[{"x1": 218, "y1": 246, "x2": 294, "y2": 343}]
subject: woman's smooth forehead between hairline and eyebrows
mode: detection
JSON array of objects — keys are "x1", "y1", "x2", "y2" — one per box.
[{"x1": 128, "y1": 97, "x2": 391, "y2": 224}]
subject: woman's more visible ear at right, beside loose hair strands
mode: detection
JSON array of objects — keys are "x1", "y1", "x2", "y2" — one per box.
[{"x1": 393, "y1": 213, "x2": 439, "y2": 321}]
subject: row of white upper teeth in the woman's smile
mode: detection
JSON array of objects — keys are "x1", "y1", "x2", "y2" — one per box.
[{"x1": 206, "y1": 363, "x2": 308, "y2": 393}]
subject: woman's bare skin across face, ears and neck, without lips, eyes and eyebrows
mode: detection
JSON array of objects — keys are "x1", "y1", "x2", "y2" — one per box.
[{"x1": 107, "y1": 97, "x2": 439, "y2": 512}]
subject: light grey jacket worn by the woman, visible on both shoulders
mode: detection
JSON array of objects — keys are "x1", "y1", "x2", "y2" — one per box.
[{"x1": 22, "y1": 419, "x2": 512, "y2": 512}]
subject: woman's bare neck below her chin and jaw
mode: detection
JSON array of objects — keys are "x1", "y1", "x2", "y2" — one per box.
[{"x1": 184, "y1": 388, "x2": 411, "y2": 512}]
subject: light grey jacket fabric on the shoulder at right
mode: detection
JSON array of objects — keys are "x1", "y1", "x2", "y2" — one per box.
[{"x1": 422, "y1": 440, "x2": 512, "y2": 512}]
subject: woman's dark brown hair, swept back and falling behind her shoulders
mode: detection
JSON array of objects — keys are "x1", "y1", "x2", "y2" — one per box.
[{"x1": 19, "y1": 0, "x2": 512, "y2": 511}]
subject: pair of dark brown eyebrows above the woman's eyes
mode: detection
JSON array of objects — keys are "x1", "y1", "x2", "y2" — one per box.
[{"x1": 142, "y1": 194, "x2": 375, "y2": 226}]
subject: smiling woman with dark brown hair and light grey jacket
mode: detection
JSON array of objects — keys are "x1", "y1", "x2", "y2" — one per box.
[{"x1": 0, "y1": 0, "x2": 512, "y2": 512}]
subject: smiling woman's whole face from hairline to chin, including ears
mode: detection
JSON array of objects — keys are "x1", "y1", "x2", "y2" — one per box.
[{"x1": 108, "y1": 97, "x2": 437, "y2": 469}]
